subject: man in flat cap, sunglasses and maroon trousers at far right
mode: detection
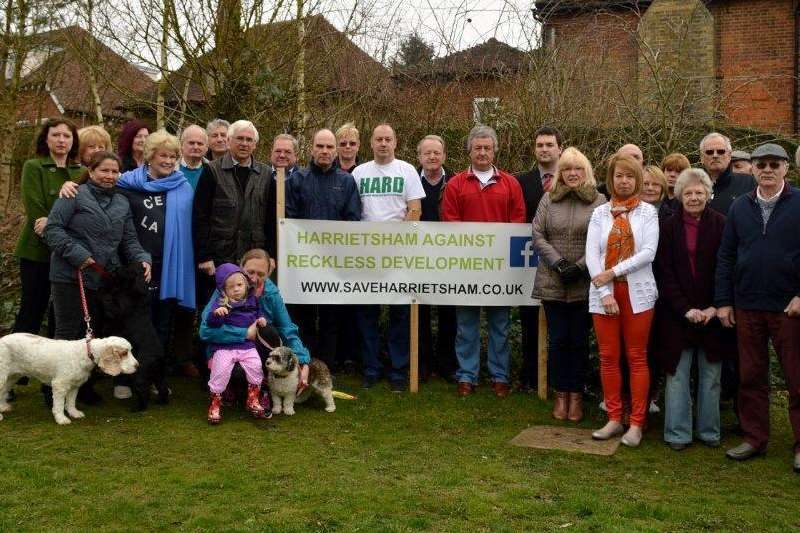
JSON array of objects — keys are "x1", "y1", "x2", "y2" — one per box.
[{"x1": 715, "y1": 144, "x2": 800, "y2": 473}]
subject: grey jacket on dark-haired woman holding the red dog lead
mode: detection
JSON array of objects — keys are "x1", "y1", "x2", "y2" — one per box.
[{"x1": 44, "y1": 183, "x2": 151, "y2": 289}]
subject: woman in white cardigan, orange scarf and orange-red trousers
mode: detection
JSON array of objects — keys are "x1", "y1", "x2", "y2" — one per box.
[{"x1": 586, "y1": 155, "x2": 658, "y2": 447}]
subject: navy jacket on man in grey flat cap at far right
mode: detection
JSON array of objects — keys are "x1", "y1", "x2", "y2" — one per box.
[{"x1": 714, "y1": 181, "x2": 800, "y2": 312}]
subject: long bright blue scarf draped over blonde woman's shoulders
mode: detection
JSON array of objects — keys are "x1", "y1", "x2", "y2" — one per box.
[{"x1": 117, "y1": 165, "x2": 195, "y2": 309}]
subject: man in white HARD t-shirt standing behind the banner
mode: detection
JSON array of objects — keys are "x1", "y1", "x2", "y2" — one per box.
[{"x1": 353, "y1": 124, "x2": 425, "y2": 392}]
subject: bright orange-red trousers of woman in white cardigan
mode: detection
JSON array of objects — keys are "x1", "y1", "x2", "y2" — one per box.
[{"x1": 592, "y1": 281, "x2": 653, "y2": 427}]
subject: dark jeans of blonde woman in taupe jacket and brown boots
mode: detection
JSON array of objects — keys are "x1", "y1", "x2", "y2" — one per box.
[{"x1": 534, "y1": 302, "x2": 592, "y2": 392}]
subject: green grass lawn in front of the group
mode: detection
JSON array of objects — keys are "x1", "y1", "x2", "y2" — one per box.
[{"x1": 0, "y1": 378, "x2": 800, "y2": 532}]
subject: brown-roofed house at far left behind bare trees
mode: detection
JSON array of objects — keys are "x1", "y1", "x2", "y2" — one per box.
[{"x1": 17, "y1": 26, "x2": 155, "y2": 127}]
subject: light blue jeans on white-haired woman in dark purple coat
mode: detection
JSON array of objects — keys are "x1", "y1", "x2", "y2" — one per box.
[{"x1": 664, "y1": 348, "x2": 722, "y2": 444}]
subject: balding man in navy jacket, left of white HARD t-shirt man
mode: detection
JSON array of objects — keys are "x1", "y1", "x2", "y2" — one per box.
[{"x1": 286, "y1": 129, "x2": 361, "y2": 369}]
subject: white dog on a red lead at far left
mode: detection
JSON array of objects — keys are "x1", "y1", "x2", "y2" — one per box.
[{"x1": 0, "y1": 333, "x2": 139, "y2": 425}]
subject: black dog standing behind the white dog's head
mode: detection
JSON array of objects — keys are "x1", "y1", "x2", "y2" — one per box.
[{"x1": 100, "y1": 262, "x2": 169, "y2": 411}]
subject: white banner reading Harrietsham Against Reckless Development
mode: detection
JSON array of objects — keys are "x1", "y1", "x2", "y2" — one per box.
[{"x1": 278, "y1": 219, "x2": 538, "y2": 306}]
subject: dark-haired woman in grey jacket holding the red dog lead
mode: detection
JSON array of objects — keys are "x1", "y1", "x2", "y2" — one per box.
[{"x1": 44, "y1": 152, "x2": 151, "y2": 397}]
